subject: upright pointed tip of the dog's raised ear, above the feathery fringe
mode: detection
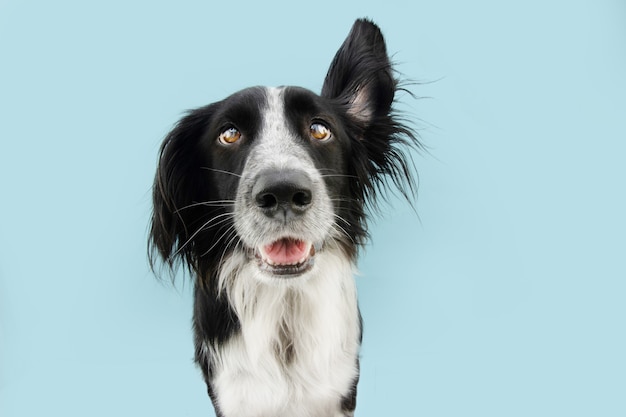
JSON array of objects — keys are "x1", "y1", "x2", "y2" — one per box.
[{"x1": 322, "y1": 19, "x2": 396, "y2": 126}]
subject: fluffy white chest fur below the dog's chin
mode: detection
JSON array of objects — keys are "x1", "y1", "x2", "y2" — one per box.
[{"x1": 209, "y1": 250, "x2": 360, "y2": 417}]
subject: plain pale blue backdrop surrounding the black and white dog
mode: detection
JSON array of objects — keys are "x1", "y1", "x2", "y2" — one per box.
[{"x1": 0, "y1": 0, "x2": 626, "y2": 417}]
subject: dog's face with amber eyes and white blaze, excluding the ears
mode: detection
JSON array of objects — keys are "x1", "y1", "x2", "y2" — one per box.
[{"x1": 196, "y1": 87, "x2": 350, "y2": 279}]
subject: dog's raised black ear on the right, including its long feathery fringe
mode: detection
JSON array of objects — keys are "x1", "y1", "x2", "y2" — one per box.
[{"x1": 322, "y1": 19, "x2": 421, "y2": 219}]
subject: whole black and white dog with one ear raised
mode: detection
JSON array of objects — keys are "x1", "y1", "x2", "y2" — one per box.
[{"x1": 149, "y1": 19, "x2": 419, "y2": 417}]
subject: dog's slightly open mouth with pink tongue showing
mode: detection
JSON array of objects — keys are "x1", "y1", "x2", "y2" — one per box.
[{"x1": 255, "y1": 237, "x2": 315, "y2": 277}]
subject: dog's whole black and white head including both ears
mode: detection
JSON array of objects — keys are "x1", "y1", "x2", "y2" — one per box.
[{"x1": 150, "y1": 20, "x2": 417, "y2": 286}]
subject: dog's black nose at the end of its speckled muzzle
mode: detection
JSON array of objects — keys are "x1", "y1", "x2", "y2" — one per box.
[{"x1": 252, "y1": 169, "x2": 313, "y2": 220}]
